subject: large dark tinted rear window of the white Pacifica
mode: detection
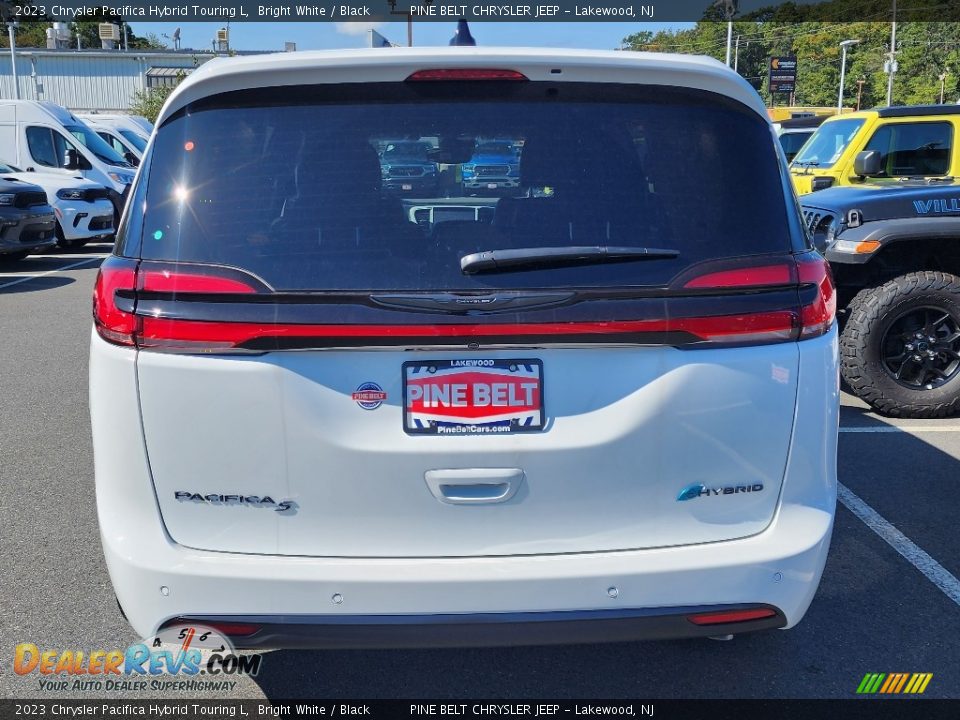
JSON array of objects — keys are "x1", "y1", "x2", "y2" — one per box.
[{"x1": 141, "y1": 82, "x2": 791, "y2": 291}]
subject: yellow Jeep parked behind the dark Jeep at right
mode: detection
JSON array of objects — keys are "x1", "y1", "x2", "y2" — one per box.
[{"x1": 790, "y1": 105, "x2": 960, "y2": 195}]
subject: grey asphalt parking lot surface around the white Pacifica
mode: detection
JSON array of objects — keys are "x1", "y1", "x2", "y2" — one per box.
[{"x1": 0, "y1": 250, "x2": 960, "y2": 699}]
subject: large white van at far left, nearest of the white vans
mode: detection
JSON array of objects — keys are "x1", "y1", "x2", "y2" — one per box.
[{"x1": 0, "y1": 100, "x2": 136, "y2": 221}]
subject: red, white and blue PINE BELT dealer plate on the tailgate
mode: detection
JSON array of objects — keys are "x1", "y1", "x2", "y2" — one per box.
[{"x1": 403, "y1": 358, "x2": 545, "y2": 435}]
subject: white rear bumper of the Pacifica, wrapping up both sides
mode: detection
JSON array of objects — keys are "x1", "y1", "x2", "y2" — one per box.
[{"x1": 90, "y1": 329, "x2": 839, "y2": 646}]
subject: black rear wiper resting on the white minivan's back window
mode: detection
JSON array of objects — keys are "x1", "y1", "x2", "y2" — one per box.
[{"x1": 460, "y1": 245, "x2": 680, "y2": 275}]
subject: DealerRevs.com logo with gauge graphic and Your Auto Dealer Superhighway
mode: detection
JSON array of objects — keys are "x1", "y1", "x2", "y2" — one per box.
[{"x1": 13, "y1": 624, "x2": 263, "y2": 692}]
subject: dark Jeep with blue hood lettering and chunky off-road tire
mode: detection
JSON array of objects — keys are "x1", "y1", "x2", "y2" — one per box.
[{"x1": 801, "y1": 178, "x2": 960, "y2": 418}]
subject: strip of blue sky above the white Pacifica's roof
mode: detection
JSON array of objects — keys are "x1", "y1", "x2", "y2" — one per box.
[{"x1": 130, "y1": 21, "x2": 692, "y2": 50}]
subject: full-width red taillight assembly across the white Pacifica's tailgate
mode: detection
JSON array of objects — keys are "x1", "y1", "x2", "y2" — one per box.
[{"x1": 93, "y1": 252, "x2": 837, "y2": 352}]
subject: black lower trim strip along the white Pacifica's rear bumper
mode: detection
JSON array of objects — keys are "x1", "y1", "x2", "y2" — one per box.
[{"x1": 159, "y1": 605, "x2": 787, "y2": 648}]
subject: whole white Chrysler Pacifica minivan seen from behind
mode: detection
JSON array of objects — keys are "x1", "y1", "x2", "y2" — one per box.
[{"x1": 90, "y1": 48, "x2": 839, "y2": 647}]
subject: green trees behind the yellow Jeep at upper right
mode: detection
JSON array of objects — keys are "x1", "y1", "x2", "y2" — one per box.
[{"x1": 624, "y1": 21, "x2": 960, "y2": 108}]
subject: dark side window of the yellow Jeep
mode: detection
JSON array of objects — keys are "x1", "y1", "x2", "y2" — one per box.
[{"x1": 864, "y1": 122, "x2": 953, "y2": 177}]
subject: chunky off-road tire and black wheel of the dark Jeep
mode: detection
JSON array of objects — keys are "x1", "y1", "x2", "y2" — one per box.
[{"x1": 840, "y1": 270, "x2": 960, "y2": 418}]
